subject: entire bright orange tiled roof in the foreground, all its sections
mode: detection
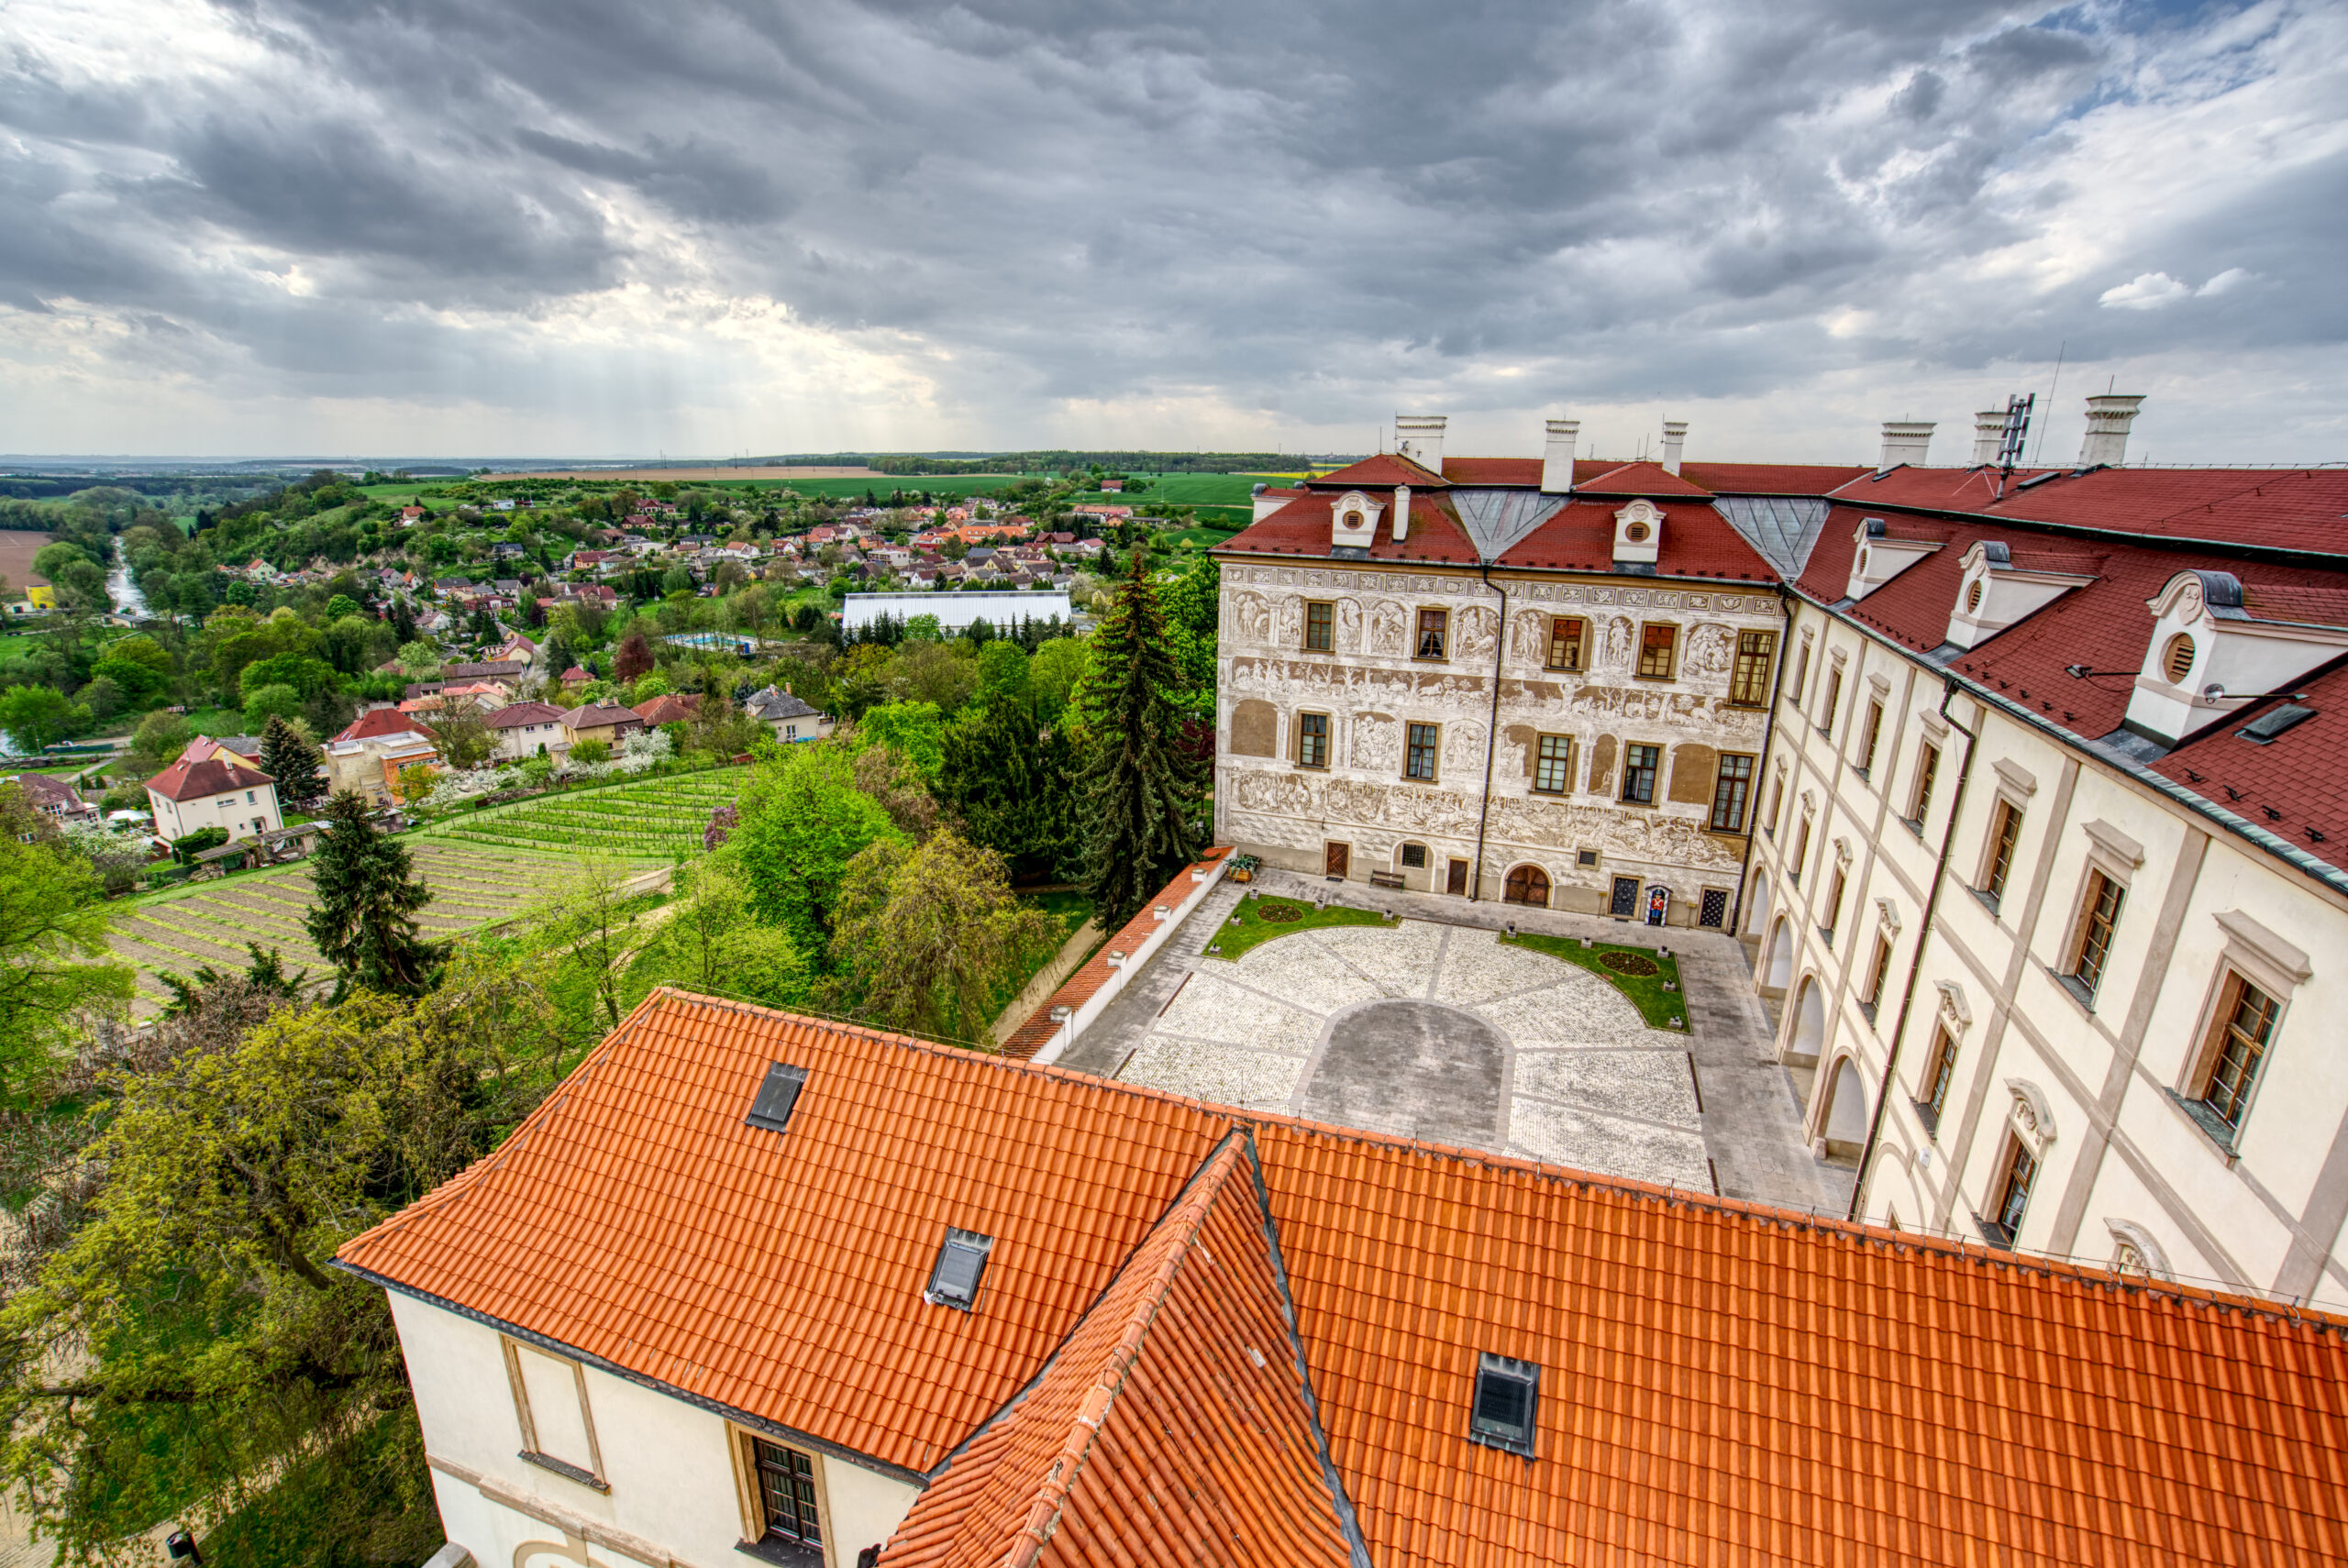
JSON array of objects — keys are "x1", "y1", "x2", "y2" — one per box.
[{"x1": 338, "y1": 990, "x2": 2348, "y2": 1568}]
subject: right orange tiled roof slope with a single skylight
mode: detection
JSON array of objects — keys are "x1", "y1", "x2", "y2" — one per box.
[{"x1": 1258, "y1": 1124, "x2": 2348, "y2": 1568}]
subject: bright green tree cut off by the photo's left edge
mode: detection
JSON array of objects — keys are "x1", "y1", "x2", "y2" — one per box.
[{"x1": 0, "y1": 821, "x2": 131, "y2": 1106}]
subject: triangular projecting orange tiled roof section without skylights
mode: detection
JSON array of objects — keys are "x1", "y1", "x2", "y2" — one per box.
[{"x1": 880, "y1": 1136, "x2": 1353, "y2": 1568}]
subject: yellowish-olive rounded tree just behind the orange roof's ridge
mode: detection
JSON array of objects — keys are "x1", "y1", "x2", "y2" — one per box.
[{"x1": 831, "y1": 829, "x2": 1059, "y2": 1043}]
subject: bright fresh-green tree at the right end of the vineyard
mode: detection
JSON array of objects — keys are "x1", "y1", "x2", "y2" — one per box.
[{"x1": 728, "y1": 746, "x2": 902, "y2": 955}]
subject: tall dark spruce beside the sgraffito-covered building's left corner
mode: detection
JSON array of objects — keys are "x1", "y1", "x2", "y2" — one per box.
[{"x1": 1078, "y1": 552, "x2": 1202, "y2": 930}]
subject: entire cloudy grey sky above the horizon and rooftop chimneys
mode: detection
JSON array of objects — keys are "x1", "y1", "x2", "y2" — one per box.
[{"x1": 0, "y1": 0, "x2": 2348, "y2": 462}]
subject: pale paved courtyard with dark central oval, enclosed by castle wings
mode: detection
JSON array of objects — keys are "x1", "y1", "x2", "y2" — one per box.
[{"x1": 1059, "y1": 871, "x2": 1853, "y2": 1213}]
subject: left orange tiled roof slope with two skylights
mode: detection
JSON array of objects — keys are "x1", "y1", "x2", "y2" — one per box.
[{"x1": 338, "y1": 988, "x2": 1224, "y2": 1472}]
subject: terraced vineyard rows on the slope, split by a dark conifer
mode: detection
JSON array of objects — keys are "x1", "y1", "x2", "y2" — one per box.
[{"x1": 98, "y1": 767, "x2": 747, "y2": 1016}]
